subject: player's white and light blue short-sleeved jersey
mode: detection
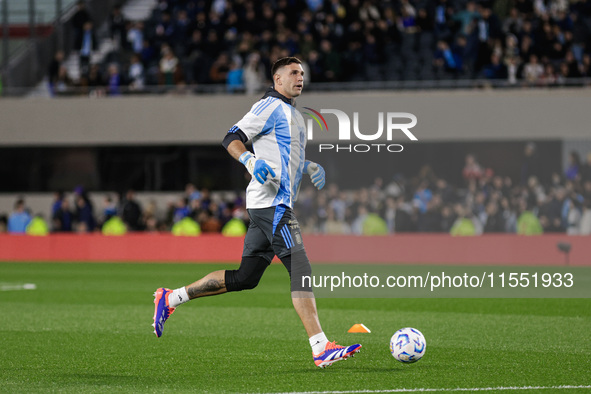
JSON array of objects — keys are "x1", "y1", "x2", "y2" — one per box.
[{"x1": 230, "y1": 88, "x2": 306, "y2": 208}]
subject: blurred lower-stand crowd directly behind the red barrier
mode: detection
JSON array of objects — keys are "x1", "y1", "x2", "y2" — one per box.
[{"x1": 0, "y1": 148, "x2": 591, "y2": 235}]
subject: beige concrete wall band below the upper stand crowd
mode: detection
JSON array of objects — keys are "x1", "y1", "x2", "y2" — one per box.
[{"x1": 0, "y1": 88, "x2": 591, "y2": 146}]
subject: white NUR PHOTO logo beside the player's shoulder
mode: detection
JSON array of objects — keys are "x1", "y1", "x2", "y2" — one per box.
[{"x1": 304, "y1": 107, "x2": 418, "y2": 153}]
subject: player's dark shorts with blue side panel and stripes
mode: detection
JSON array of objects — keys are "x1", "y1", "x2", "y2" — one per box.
[{"x1": 242, "y1": 205, "x2": 304, "y2": 262}]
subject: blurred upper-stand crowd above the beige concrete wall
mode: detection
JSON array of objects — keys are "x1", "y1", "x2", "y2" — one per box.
[{"x1": 49, "y1": 0, "x2": 591, "y2": 95}]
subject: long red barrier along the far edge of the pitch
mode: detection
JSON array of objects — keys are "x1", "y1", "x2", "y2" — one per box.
[{"x1": 0, "y1": 234, "x2": 591, "y2": 266}]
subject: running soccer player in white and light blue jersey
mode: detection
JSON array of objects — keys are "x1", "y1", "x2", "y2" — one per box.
[{"x1": 154, "y1": 57, "x2": 361, "y2": 368}]
